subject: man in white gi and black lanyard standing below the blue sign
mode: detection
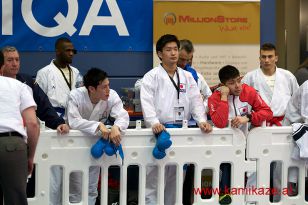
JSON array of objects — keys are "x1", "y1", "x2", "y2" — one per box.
[{"x1": 36, "y1": 37, "x2": 79, "y2": 205}]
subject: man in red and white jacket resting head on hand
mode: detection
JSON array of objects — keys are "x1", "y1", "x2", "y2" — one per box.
[{"x1": 208, "y1": 65, "x2": 273, "y2": 204}]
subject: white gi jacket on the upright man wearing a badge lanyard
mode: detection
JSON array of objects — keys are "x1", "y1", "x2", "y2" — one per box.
[{"x1": 140, "y1": 65, "x2": 206, "y2": 127}]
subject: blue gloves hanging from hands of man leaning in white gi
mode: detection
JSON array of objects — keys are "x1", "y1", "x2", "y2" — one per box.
[{"x1": 91, "y1": 138, "x2": 124, "y2": 164}]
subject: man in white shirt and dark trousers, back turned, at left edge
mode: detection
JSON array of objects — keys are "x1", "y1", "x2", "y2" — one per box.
[{"x1": 0, "y1": 52, "x2": 39, "y2": 205}]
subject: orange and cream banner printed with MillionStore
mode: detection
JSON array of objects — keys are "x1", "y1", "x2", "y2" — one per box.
[{"x1": 153, "y1": 1, "x2": 260, "y2": 85}]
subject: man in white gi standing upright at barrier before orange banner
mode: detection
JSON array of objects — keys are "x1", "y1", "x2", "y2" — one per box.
[{"x1": 140, "y1": 34, "x2": 212, "y2": 205}]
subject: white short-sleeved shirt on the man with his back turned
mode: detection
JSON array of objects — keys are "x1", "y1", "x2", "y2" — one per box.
[{"x1": 0, "y1": 76, "x2": 36, "y2": 140}]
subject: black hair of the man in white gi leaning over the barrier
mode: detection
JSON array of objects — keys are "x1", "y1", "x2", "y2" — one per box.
[{"x1": 83, "y1": 68, "x2": 108, "y2": 89}]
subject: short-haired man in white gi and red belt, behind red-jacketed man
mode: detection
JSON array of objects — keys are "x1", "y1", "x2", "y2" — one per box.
[{"x1": 242, "y1": 43, "x2": 299, "y2": 201}]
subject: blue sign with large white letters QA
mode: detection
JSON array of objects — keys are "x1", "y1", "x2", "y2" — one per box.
[{"x1": 0, "y1": 0, "x2": 153, "y2": 51}]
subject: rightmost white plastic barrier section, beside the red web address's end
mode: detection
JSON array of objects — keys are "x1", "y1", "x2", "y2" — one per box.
[{"x1": 247, "y1": 127, "x2": 308, "y2": 205}]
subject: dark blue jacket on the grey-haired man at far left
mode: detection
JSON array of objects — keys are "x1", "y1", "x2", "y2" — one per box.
[{"x1": 16, "y1": 74, "x2": 65, "y2": 129}]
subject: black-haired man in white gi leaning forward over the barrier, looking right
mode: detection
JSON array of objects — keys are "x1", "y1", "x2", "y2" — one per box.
[{"x1": 67, "y1": 68, "x2": 129, "y2": 205}]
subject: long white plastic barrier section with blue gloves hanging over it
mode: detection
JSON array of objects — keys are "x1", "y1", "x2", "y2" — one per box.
[{"x1": 29, "y1": 128, "x2": 256, "y2": 205}]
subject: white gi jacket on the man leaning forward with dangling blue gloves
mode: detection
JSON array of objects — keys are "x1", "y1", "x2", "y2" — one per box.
[{"x1": 66, "y1": 87, "x2": 129, "y2": 135}]
